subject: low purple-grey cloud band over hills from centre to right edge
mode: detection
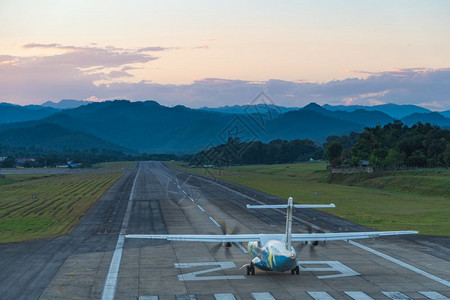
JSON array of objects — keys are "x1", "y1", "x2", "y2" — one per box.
[{"x1": 89, "y1": 68, "x2": 450, "y2": 110}]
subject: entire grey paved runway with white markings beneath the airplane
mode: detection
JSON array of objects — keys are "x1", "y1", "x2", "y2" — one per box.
[{"x1": 0, "y1": 162, "x2": 450, "y2": 300}]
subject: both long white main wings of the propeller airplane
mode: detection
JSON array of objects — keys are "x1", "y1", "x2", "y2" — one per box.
[{"x1": 125, "y1": 231, "x2": 418, "y2": 243}]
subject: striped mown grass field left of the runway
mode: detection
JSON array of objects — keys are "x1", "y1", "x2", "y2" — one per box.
[{"x1": 0, "y1": 163, "x2": 134, "y2": 243}]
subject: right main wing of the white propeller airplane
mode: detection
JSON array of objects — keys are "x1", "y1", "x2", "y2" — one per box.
[{"x1": 292, "y1": 230, "x2": 419, "y2": 242}]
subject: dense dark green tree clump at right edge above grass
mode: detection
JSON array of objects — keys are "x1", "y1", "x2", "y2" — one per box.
[{"x1": 325, "y1": 121, "x2": 450, "y2": 168}]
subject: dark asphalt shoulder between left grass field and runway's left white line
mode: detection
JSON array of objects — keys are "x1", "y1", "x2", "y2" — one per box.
[{"x1": 0, "y1": 165, "x2": 136, "y2": 299}]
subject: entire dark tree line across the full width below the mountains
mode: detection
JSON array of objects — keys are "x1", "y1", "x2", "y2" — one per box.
[{"x1": 0, "y1": 121, "x2": 450, "y2": 168}]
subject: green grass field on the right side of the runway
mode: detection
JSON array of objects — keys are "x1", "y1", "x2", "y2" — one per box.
[{"x1": 172, "y1": 163, "x2": 450, "y2": 236}]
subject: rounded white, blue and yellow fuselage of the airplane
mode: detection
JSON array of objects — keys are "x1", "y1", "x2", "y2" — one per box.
[{"x1": 247, "y1": 240, "x2": 298, "y2": 272}]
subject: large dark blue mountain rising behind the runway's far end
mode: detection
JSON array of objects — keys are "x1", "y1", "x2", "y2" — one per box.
[{"x1": 39, "y1": 100, "x2": 233, "y2": 153}]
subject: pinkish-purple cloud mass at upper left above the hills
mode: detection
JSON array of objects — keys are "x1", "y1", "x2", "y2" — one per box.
[{"x1": 0, "y1": 43, "x2": 158, "y2": 103}]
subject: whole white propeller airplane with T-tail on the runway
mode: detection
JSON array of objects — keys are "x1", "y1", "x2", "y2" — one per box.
[{"x1": 125, "y1": 197, "x2": 419, "y2": 275}]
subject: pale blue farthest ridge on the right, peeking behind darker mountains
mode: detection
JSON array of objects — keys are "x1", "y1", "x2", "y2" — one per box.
[{"x1": 323, "y1": 103, "x2": 431, "y2": 120}]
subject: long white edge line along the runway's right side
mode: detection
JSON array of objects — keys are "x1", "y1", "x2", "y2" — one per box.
[{"x1": 193, "y1": 172, "x2": 450, "y2": 287}]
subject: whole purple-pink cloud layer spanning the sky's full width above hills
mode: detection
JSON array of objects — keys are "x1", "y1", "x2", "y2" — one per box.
[{"x1": 0, "y1": 43, "x2": 450, "y2": 110}]
